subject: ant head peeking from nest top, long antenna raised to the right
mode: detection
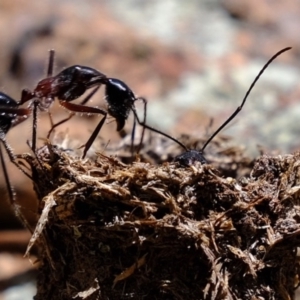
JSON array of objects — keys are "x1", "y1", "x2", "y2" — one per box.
[{"x1": 174, "y1": 47, "x2": 291, "y2": 166}]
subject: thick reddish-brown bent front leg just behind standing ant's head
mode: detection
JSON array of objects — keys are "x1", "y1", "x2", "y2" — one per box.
[{"x1": 60, "y1": 101, "x2": 107, "y2": 159}]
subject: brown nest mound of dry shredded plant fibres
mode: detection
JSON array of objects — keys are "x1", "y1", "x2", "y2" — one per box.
[{"x1": 25, "y1": 135, "x2": 300, "y2": 300}]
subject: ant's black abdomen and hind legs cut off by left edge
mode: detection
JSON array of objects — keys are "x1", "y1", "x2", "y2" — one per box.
[{"x1": 0, "y1": 92, "x2": 32, "y2": 229}]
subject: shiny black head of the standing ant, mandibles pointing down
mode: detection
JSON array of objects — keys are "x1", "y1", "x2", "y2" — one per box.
[{"x1": 105, "y1": 78, "x2": 136, "y2": 131}]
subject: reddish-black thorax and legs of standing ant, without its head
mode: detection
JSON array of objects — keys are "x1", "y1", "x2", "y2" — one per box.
[{"x1": 18, "y1": 50, "x2": 106, "y2": 152}]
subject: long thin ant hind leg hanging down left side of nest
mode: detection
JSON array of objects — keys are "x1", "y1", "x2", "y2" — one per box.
[{"x1": 0, "y1": 145, "x2": 33, "y2": 233}]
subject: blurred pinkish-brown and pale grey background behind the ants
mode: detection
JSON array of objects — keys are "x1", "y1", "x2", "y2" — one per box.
[{"x1": 0, "y1": 0, "x2": 300, "y2": 300}]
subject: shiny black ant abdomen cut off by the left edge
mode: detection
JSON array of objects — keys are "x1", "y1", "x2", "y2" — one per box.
[{"x1": 0, "y1": 92, "x2": 18, "y2": 133}]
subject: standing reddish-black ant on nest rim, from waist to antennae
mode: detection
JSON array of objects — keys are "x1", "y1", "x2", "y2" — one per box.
[{"x1": 19, "y1": 50, "x2": 188, "y2": 158}]
